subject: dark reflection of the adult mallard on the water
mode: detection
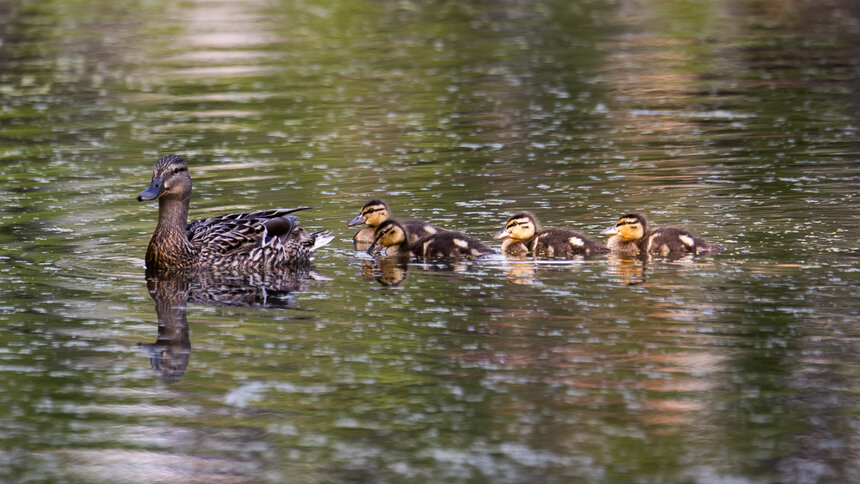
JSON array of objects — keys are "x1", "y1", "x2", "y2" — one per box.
[{"x1": 138, "y1": 269, "x2": 316, "y2": 383}]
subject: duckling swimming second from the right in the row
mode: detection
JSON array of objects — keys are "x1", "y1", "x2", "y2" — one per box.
[{"x1": 493, "y1": 212, "x2": 609, "y2": 258}]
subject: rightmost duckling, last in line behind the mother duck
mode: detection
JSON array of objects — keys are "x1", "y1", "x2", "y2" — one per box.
[{"x1": 600, "y1": 212, "x2": 725, "y2": 256}]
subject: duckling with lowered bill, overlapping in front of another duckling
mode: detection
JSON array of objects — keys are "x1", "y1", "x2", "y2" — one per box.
[{"x1": 367, "y1": 220, "x2": 496, "y2": 260}]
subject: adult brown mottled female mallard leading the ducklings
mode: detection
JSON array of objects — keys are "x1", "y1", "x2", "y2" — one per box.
[{"x1": 137, "y1": 155, "x2": 333, "y2": 271}]
